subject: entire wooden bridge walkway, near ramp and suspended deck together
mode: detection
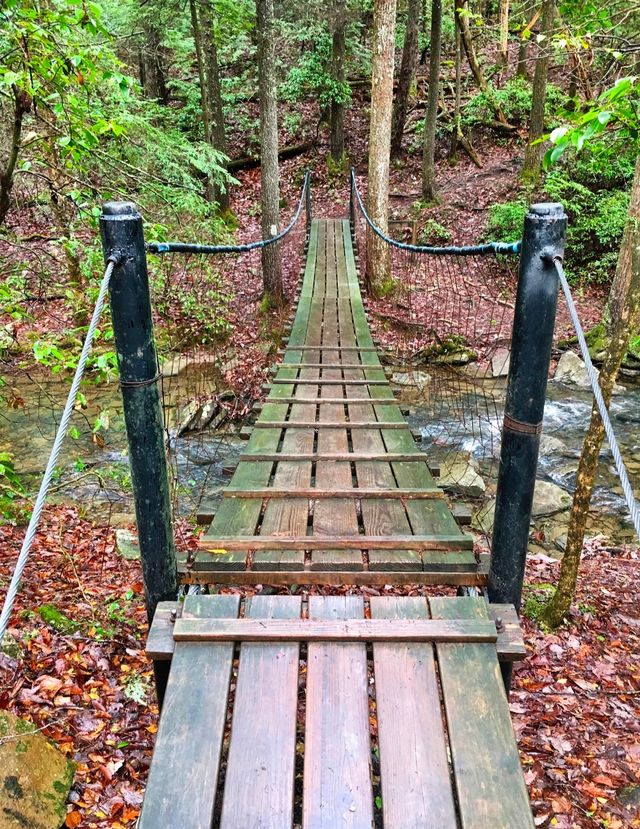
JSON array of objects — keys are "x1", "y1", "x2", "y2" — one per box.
[{"x1": 138, "y1": 221, "x2": 533, "y2": 829}]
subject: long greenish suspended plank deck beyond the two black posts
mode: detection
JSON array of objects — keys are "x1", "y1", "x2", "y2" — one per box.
[{"x1": 180, "y1": 220, "x2": 487, "y2": 585}]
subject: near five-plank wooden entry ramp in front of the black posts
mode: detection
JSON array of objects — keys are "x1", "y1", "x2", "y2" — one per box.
[{"x1": 138, "y1": 596, "x2": 533, "y2": 829}]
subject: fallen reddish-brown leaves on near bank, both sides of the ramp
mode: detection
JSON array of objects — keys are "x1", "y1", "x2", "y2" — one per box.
[{"x1": 0, "y1": 507, "x2": 640, "y2": 829}]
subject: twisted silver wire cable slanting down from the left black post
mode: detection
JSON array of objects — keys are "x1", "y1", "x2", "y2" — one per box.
[{"x1": 0, "y1": 256, "x2": 118, "y2": 642}]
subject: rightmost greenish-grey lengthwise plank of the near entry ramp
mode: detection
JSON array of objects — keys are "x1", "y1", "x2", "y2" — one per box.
[{"x1": 429, "y1": 597, "x2": 534, "y2": 829}]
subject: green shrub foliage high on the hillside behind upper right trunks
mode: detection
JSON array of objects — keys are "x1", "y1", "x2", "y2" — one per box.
[{"x1": 462, "y1": 78, "x2": 567, "y2": 127}]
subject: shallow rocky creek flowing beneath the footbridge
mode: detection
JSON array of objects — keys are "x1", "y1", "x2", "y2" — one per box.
[{"x1": 0, "y1": 361, "x2": 640, "y2": 554}]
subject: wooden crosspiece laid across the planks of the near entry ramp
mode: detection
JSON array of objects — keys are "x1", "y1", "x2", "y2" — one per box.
[{"x1": 173, "y1": 616, "x2": 498, "y2": 642}]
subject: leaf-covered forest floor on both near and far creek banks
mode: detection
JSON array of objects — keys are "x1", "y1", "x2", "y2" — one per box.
[{"x1": 0, "y1": 100, "x2": 640, "y2": 829}]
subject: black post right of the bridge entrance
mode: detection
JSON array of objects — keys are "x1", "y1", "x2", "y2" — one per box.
[{"x1": 488, "y1": 204, "x2": 567, "y2": 691}]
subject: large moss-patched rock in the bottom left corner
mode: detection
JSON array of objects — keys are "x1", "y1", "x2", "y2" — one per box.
[{"x1": 0, "y1": 711, "x2": 75, "y2": 829}]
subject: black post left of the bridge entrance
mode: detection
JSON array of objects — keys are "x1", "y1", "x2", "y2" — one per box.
[{"x1": 100, "y1": 202, "x2": 179, "y2": 703}]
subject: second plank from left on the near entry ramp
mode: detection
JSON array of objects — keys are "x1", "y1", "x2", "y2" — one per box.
[{"x1": 219, "y1": 596, "x2": 302, "y2": 829}]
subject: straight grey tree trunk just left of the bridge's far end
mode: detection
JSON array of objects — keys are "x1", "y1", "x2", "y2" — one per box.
[{"x1": 256, "y1": 0, "x2": 284, "y2": 307}]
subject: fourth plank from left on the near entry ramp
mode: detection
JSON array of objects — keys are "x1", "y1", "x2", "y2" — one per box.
[{"x1": 371, "y1": 597, "x2": 457, "y2": 829}]
